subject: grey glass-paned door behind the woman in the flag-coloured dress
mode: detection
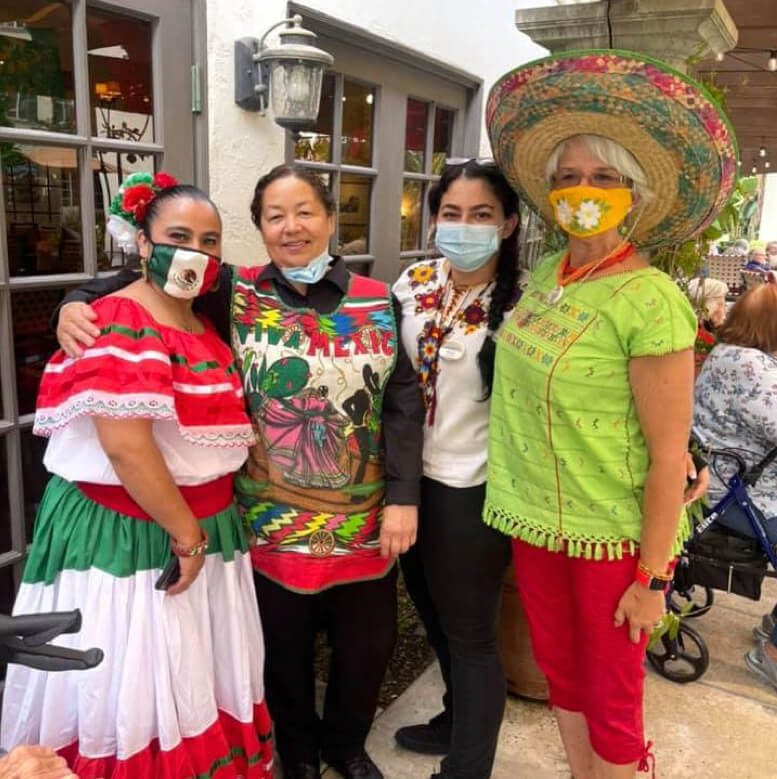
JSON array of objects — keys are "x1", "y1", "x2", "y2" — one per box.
[{"x1": 0, "y1": 0, "x2": 195, "y2": 620}]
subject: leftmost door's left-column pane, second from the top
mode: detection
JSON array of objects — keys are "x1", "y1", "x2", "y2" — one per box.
[{"x1": 0, "y1": 144, "x2": 84, "y2": 276}]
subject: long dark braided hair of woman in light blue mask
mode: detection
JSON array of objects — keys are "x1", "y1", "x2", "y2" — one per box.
[{"x1": 429, "y1": 160, "x2": 520, "y2": 400}]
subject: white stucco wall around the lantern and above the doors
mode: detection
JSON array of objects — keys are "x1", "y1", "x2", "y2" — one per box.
[{"x1": 207, "y1": 0, "x2": 547, "y2": 263}]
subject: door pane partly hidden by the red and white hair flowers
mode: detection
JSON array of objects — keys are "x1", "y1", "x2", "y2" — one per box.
[{"x1": 92, "y1": 149, "x2": 156, "y2": 271}]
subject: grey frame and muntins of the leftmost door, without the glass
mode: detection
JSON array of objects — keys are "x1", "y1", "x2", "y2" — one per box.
[{"x1": 0, "y1": 0, "x2": 207, "y2": 604}]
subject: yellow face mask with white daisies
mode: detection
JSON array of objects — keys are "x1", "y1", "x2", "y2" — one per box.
[{"x1": 548, "y1": 185, "x2": 632, "y2": 238}]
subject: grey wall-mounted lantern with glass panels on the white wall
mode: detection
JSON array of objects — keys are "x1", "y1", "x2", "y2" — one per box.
[{"x1": 235, "y1": 14, "x2": 334, "y2": 132}]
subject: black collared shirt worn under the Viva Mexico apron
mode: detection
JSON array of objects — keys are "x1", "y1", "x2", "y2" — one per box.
[{"x1": 60, "y1": 257, "x2": 424, "y2": 505}]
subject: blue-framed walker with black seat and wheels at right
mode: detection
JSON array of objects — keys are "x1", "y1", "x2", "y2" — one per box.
[{"x1": 647, "y1": 447, "x2": 777, "y2": 684}]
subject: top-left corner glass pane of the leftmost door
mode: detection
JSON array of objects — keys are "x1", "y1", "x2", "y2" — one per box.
[{"x1": 0, "y1": 0, "x2": 76, "y2": 133}]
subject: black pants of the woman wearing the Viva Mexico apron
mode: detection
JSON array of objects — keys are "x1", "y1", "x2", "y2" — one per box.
[{"x1": 255, "y1": 566, "x2": 397, "y2": 765}]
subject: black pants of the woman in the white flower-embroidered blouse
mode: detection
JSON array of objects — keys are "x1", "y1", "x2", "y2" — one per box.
[{"x1": 401, "y1": 478, "x2": 510, "y2": 779}]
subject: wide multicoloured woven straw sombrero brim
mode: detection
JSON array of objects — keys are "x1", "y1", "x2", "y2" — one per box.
[{"x1": 486, "y1": 49, "x2": 738, "y2": 247}]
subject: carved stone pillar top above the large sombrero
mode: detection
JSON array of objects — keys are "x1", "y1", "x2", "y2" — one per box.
[{"x1": 515, "y1": 0, "x2": 737, "y2": 73}]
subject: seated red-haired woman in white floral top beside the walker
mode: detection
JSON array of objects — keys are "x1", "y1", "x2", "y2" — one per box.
[{"x1": 693, "y1": 282, "x2": 777, "y2": 687}]
